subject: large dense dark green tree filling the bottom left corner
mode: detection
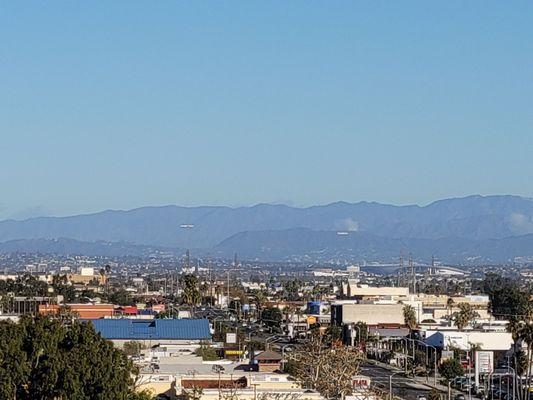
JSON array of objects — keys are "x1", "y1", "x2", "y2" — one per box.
[{"x1": 0, "y1": 315, "x2": 149, "y2": 400}]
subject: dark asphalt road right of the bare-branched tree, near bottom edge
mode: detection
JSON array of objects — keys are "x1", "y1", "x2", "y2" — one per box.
[{"x1": 361, "y1": 363, "x2": 429, "y2": 400}]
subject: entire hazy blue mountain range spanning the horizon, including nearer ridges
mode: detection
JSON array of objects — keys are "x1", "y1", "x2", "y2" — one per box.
[{"x1": 0, "y1": 196, "x2": 533, "y2": 262}]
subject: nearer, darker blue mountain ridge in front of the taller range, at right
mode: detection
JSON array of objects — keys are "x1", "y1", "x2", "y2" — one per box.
[{"x1": 216, "y1": 228, "x2": 533, "y2": 264}]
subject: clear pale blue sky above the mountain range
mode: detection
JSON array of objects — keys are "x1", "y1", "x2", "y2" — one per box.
[{"x1": 0, "y1": 1, "x2": 533, "y2": 218}]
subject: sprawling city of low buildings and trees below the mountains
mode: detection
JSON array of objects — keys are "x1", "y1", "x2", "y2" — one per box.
[{"x1": 0, "y1": 251, "x2": 533, "y2": 400}]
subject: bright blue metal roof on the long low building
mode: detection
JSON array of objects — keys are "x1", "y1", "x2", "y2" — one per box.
[{"x1": 91, "y1": 318, "x2": 211, "y2": 340}]
